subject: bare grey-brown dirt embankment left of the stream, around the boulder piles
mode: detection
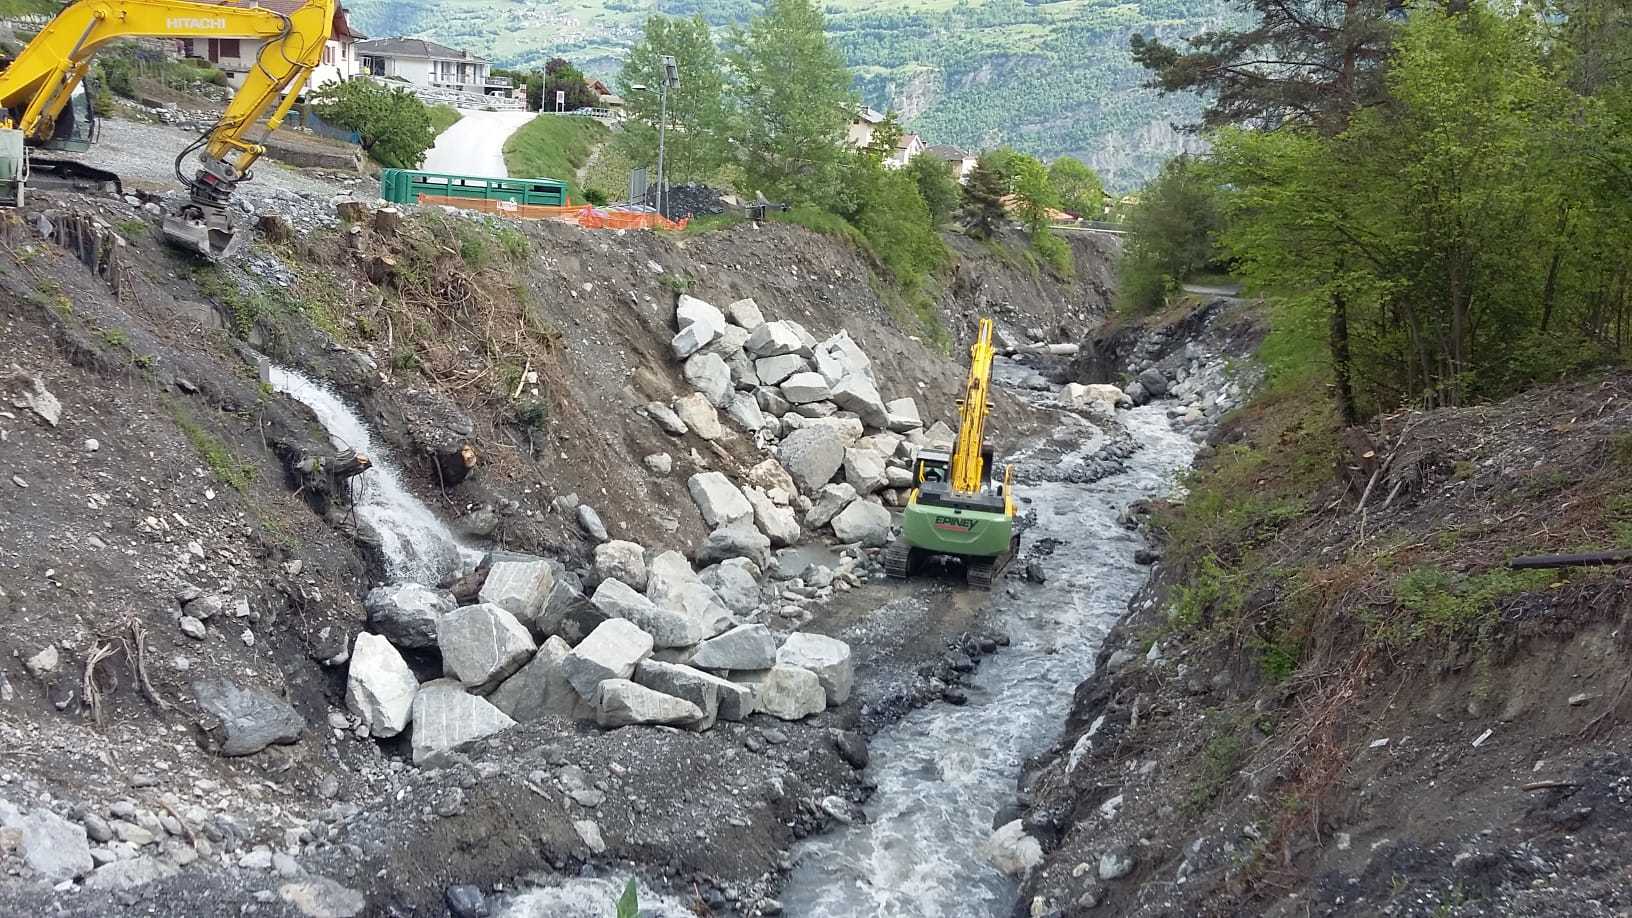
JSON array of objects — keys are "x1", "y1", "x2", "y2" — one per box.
[{"x1": 0, "y1": 182, "x2": 1102, "y2": 915}]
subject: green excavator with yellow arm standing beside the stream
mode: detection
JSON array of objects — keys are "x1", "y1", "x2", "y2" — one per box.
[{"x1": 885, "y1": 319, "x2": 1020, "y2": 590}]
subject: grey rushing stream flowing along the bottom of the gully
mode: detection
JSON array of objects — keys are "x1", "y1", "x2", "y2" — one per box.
[{"x1": 782, "y1": 388, "x2": 1195, "y2": 918}]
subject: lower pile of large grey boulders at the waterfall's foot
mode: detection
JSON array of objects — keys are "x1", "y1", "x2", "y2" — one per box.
[{"x1": 346, "y1": 542, "x2": 855, "y2": 764}]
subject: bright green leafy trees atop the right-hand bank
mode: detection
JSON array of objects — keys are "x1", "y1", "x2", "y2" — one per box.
[{"x1": 1216, "y1": 2, "x2": 1632, "y2": 413}]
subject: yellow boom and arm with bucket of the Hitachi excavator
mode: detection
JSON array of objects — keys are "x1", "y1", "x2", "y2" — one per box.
[{"x1": 0, "y1": 0, "x2": 338, "y2": 256}]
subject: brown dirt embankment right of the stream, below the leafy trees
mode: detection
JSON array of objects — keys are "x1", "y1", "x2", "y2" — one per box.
[{"x1": 1020, "y1": 308, "x2": 1632, "y2": 916}]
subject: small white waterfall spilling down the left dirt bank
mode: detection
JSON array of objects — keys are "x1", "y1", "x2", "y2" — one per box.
[{"x1": 268, "y1": 366, "x2": 468, "y2": 583}]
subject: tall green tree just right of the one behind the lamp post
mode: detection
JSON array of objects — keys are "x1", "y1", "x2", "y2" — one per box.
[{"x1": 730, "y1": 0, "x2": 857, "y2": 203}]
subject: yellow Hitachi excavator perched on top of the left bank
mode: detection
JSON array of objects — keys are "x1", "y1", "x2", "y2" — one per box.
[{"x1": 0, "y1": 0, "x2": 338, "y2": 260}]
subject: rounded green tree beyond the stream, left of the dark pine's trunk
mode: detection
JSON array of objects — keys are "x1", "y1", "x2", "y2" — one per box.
[{"x1": 1116, "y1": 157, "x2": 1222, "y2": 312}]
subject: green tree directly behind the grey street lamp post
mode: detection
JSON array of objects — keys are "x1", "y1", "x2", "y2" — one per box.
[{"x1": 617, "y1": 16, "x2": 730, "y2": 181}]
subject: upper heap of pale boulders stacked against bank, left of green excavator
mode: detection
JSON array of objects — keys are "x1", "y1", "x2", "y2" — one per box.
[{"x1": 645, "y1": 294, "x2": 951, "y2": 548}]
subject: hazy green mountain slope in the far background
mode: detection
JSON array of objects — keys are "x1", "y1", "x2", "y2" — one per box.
[{"x1": 349, "y1": 0, "x2": 1231, "y2": 189}]
